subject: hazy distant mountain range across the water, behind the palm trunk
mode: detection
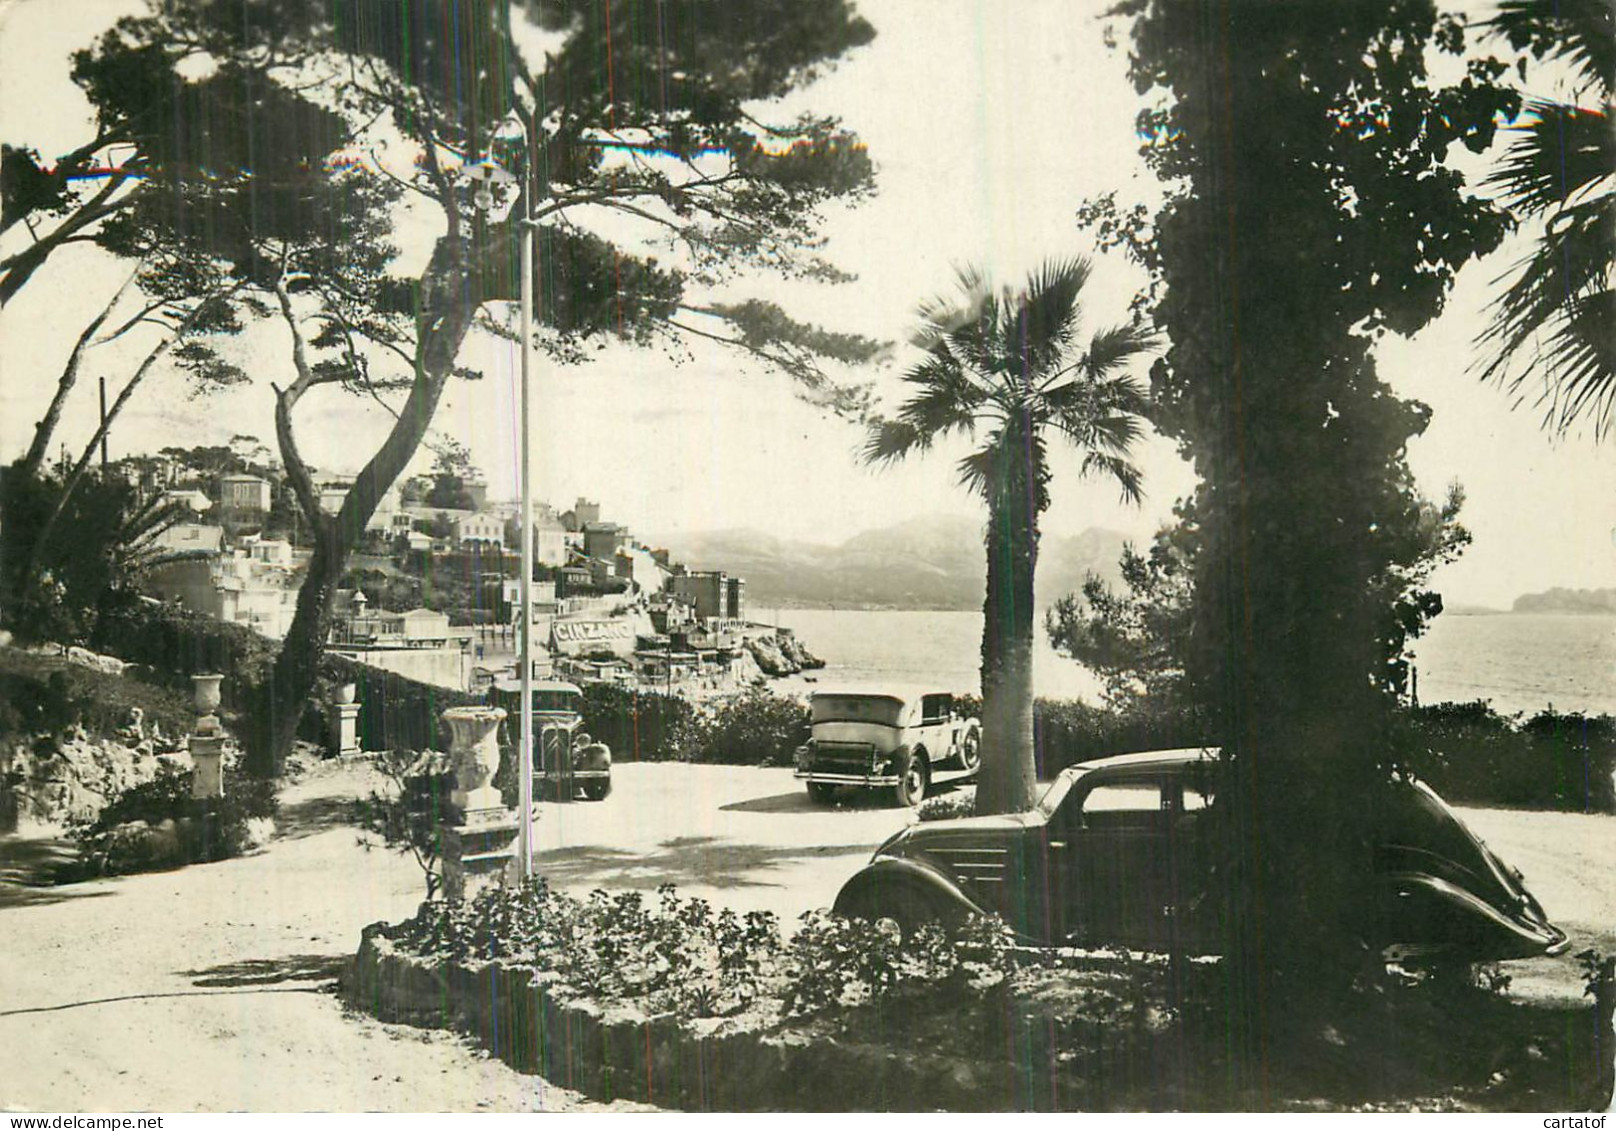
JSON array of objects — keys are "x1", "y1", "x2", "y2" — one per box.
[{"x1": 653, "y1": 515, "x2": 1126, "y2": 614}]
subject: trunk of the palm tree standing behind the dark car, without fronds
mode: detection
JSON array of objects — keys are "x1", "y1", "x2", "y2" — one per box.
[{"x1": 976, "y1": 491, "x2": 1037, "y2": 814}]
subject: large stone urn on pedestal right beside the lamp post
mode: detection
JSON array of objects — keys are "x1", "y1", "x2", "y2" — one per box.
[{"x1": 443, "y1": 706, "x2": 516, "y2": 902}]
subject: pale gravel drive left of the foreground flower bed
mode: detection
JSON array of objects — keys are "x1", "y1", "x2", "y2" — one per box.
[{"x1": 0, "y1": 767, "x2": 656, "y2": 1112}]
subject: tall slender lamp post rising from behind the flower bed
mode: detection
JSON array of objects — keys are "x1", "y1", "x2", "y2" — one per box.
[{"x1": 465, "y1": 111, "x2": 533, "y2": 881}]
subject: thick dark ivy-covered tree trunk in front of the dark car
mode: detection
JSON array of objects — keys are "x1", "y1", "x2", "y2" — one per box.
[{"x1": 1088, "y1": 0, "x2": 1519, "y2": 1034}]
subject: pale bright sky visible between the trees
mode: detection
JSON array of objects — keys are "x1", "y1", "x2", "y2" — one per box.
[{"x1": 0, "y1": 0, "x2": 1616, "y2": 608}]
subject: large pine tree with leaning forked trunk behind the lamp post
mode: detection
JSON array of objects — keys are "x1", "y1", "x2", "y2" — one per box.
[{"x1": 44, "y1": 0, "x2": 876, "y2": 774}]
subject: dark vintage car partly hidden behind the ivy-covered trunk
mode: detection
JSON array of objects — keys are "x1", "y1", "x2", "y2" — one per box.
[{"x1": 835, "y1": 750, "x2": 1568, "y2": 961}]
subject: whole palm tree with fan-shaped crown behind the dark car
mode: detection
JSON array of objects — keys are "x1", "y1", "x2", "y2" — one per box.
[{"x1": 865, "y1": 259, "x2": 1152, "y2": 813}]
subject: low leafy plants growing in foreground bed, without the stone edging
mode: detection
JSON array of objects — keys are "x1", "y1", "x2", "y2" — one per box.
[{"x1": 383, "y1": 879, "x2": 1616, "y2": 1110}]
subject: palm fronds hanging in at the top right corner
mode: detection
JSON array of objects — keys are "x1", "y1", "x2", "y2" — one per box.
[{"x1": 1479, "y1": 0, "x2": 1616, "y2": 436}]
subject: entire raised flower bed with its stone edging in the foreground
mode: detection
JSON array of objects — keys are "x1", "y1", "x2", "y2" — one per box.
[{"x1": 347, "y1": 882, "x2": 1611, "y2": 1112}]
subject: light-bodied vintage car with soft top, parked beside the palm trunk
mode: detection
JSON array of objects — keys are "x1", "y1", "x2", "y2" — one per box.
[{"x1": 797, "y1": 690, "x2": 981, "y2": 805}]
